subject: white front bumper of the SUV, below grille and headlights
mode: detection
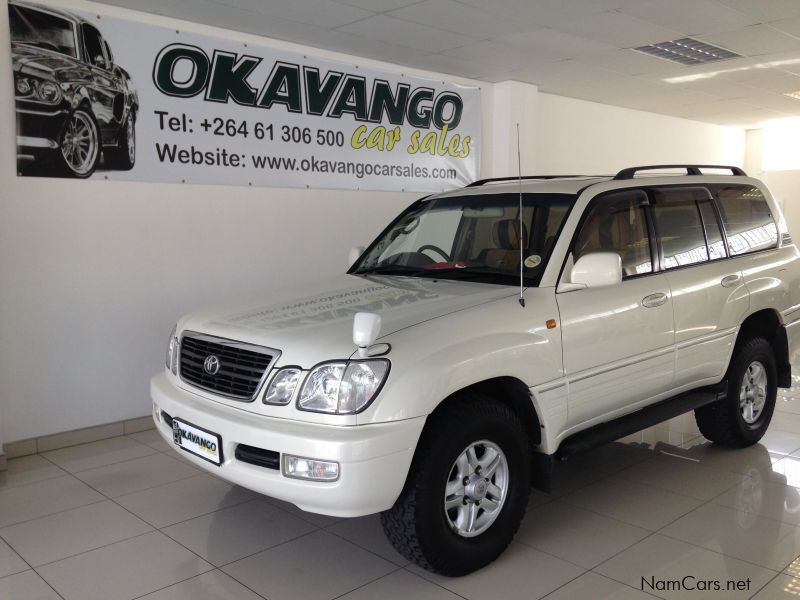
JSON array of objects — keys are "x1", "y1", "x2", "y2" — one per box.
[{"x1": 150, "y1": 373, "x2": 425, "y2": 517}]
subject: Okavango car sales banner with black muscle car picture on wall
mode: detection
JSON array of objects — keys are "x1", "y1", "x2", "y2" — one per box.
[{"x1": 8, "y1": 0, "x2": 481, "y2": 191}]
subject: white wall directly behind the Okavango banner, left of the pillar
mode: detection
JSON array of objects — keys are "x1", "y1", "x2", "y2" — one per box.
[{"x1": 0, "y1": 0, "x2": 491, "y2": 443}]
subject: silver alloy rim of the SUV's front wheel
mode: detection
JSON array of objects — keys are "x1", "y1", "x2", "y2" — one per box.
[{"x1": 444, "y1": 440, "x2": 509, "y2": 537}]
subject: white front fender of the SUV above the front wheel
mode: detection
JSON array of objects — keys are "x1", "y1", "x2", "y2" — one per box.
[{"x1": 358, "y1": 290, "x2": 563, "y2": 424}]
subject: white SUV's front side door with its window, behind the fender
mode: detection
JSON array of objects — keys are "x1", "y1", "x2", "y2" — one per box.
[{"x1": 556, "y1": 189, "x2": 674, "y2": 426}]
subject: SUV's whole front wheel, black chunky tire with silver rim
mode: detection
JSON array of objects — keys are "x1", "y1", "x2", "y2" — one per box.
[{"x1": 381, "y1": 394, "x2": 531, "y2": 577}]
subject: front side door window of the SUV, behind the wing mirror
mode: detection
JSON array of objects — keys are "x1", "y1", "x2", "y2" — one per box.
[{"x1": 573, "y1": 190, "x2": 653, "y2": 277}]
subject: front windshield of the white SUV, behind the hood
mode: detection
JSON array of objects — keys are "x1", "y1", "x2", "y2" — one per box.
[{"x1": 349, "y1": 193, "x2": 576, "y2": 286}]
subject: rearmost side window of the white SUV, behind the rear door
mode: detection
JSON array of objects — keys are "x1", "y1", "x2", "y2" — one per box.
[{"x1": 717, "y1": 185, "x2": 778, "y2": 256}]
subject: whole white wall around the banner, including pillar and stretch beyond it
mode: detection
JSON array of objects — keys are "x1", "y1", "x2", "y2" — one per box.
[{"x1": 0, "y1": 0, "x2": 744, "y2": 442}]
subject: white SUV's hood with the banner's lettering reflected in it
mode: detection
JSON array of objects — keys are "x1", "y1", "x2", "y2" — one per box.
[{"x1": 180, "y1": 275, "x2": 517, "y2": 368}]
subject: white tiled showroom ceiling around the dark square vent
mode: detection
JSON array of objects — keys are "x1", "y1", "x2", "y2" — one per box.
[{"x1": 92, "y1": 0, "x2": 800, "y2": 126}]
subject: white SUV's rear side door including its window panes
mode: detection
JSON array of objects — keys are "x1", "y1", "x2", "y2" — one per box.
[{"x1": 650, "y1": 186, "x2": 750, "y2": 388}]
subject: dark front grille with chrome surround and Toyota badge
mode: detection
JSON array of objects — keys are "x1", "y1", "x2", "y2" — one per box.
[{"x1": 180, "y1": 333, "x2": 277, "y2": 400}]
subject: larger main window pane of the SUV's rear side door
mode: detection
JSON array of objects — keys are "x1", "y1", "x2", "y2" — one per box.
[{"x1": 653, "y1": 188, "x2": 711, "y2": 269}]
